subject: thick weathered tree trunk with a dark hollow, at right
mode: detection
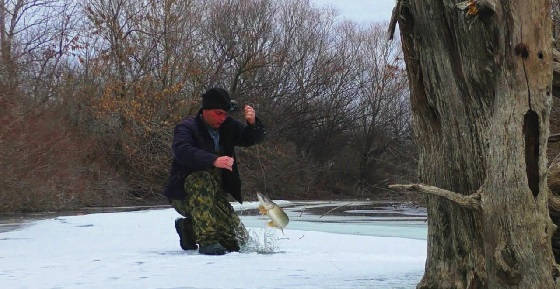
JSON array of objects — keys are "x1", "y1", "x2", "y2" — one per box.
[{"x1": 397, "y1": 0, "x2": 556, "y2": 289}]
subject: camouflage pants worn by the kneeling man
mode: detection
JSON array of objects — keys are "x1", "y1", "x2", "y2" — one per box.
[{"x1": 171, "y1": 170, "x2": 248, "y2": 251}]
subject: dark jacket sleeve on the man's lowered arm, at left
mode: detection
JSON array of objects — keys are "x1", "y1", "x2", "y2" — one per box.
[{"x1": 172, "y1": 124, "x2": 218, "y2": 170}]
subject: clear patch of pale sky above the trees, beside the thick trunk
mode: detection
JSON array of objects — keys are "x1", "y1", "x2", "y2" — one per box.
[{"x1": 312, "y1": 0, "x2": 395, "y2": 24}]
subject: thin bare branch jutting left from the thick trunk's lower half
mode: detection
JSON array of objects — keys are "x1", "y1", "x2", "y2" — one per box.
[{"x1": 389, "y1": 184, "x2": 481, "y2": 210}]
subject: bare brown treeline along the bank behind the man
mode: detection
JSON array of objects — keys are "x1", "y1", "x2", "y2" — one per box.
[{"x1": 0, "y1": 0, "x2": 415, "y2": 211}]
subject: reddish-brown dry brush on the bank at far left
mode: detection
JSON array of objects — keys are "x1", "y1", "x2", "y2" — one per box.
[{"x1": 0, "y1": 91, "x2": 126, "y2": 212}]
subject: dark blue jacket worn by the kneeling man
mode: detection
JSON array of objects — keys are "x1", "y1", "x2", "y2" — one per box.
[{"x1": 164, "y1": 111, "x2": 265, "y2": 203}]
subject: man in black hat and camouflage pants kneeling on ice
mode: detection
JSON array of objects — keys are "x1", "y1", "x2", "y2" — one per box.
[{"x1": 164, "y1": 88, "x2": 265, "y2": 255}]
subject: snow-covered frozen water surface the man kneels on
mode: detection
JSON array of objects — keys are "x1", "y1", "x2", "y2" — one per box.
[{"x1": 0, "y1": 201, "x2": 426, "y2": 289}]
